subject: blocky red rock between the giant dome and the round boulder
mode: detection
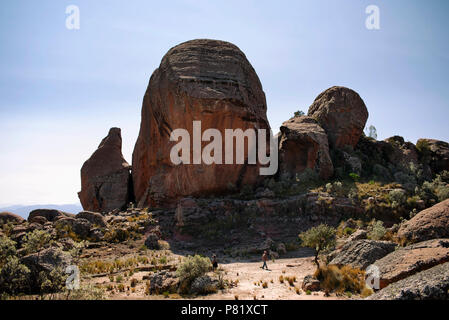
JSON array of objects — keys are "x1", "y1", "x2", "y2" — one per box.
[{"x1": 279, "y1": 116, "x2": 334, "y2": 179}]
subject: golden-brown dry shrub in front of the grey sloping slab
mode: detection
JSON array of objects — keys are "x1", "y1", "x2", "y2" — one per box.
[{"x1": 314, "y1": 265, "x2": 365, "y2": 293}]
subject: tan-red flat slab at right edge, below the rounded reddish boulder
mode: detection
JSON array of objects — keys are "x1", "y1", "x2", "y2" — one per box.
[{"x1": 374, "y1": 239, "x2": 449, "y2": 289}]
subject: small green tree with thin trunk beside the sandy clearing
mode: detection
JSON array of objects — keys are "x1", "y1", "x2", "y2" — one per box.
[{"x1": 299, "y1": 224, "x2": 336, "y2": 269}]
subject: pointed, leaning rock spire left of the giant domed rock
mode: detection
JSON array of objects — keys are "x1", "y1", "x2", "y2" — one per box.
[{"x1": 78, "y1": 128, "x2": 133, "y2": 212}]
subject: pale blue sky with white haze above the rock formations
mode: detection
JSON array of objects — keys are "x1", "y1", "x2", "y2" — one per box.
[{"x1": 0, "y1": 0, "x2": 449, "y2": 206}]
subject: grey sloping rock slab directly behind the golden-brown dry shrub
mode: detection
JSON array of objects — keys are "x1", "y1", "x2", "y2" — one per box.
[{"x1": 329, "y1": 240, "x2": 396, "y2": 269}]
